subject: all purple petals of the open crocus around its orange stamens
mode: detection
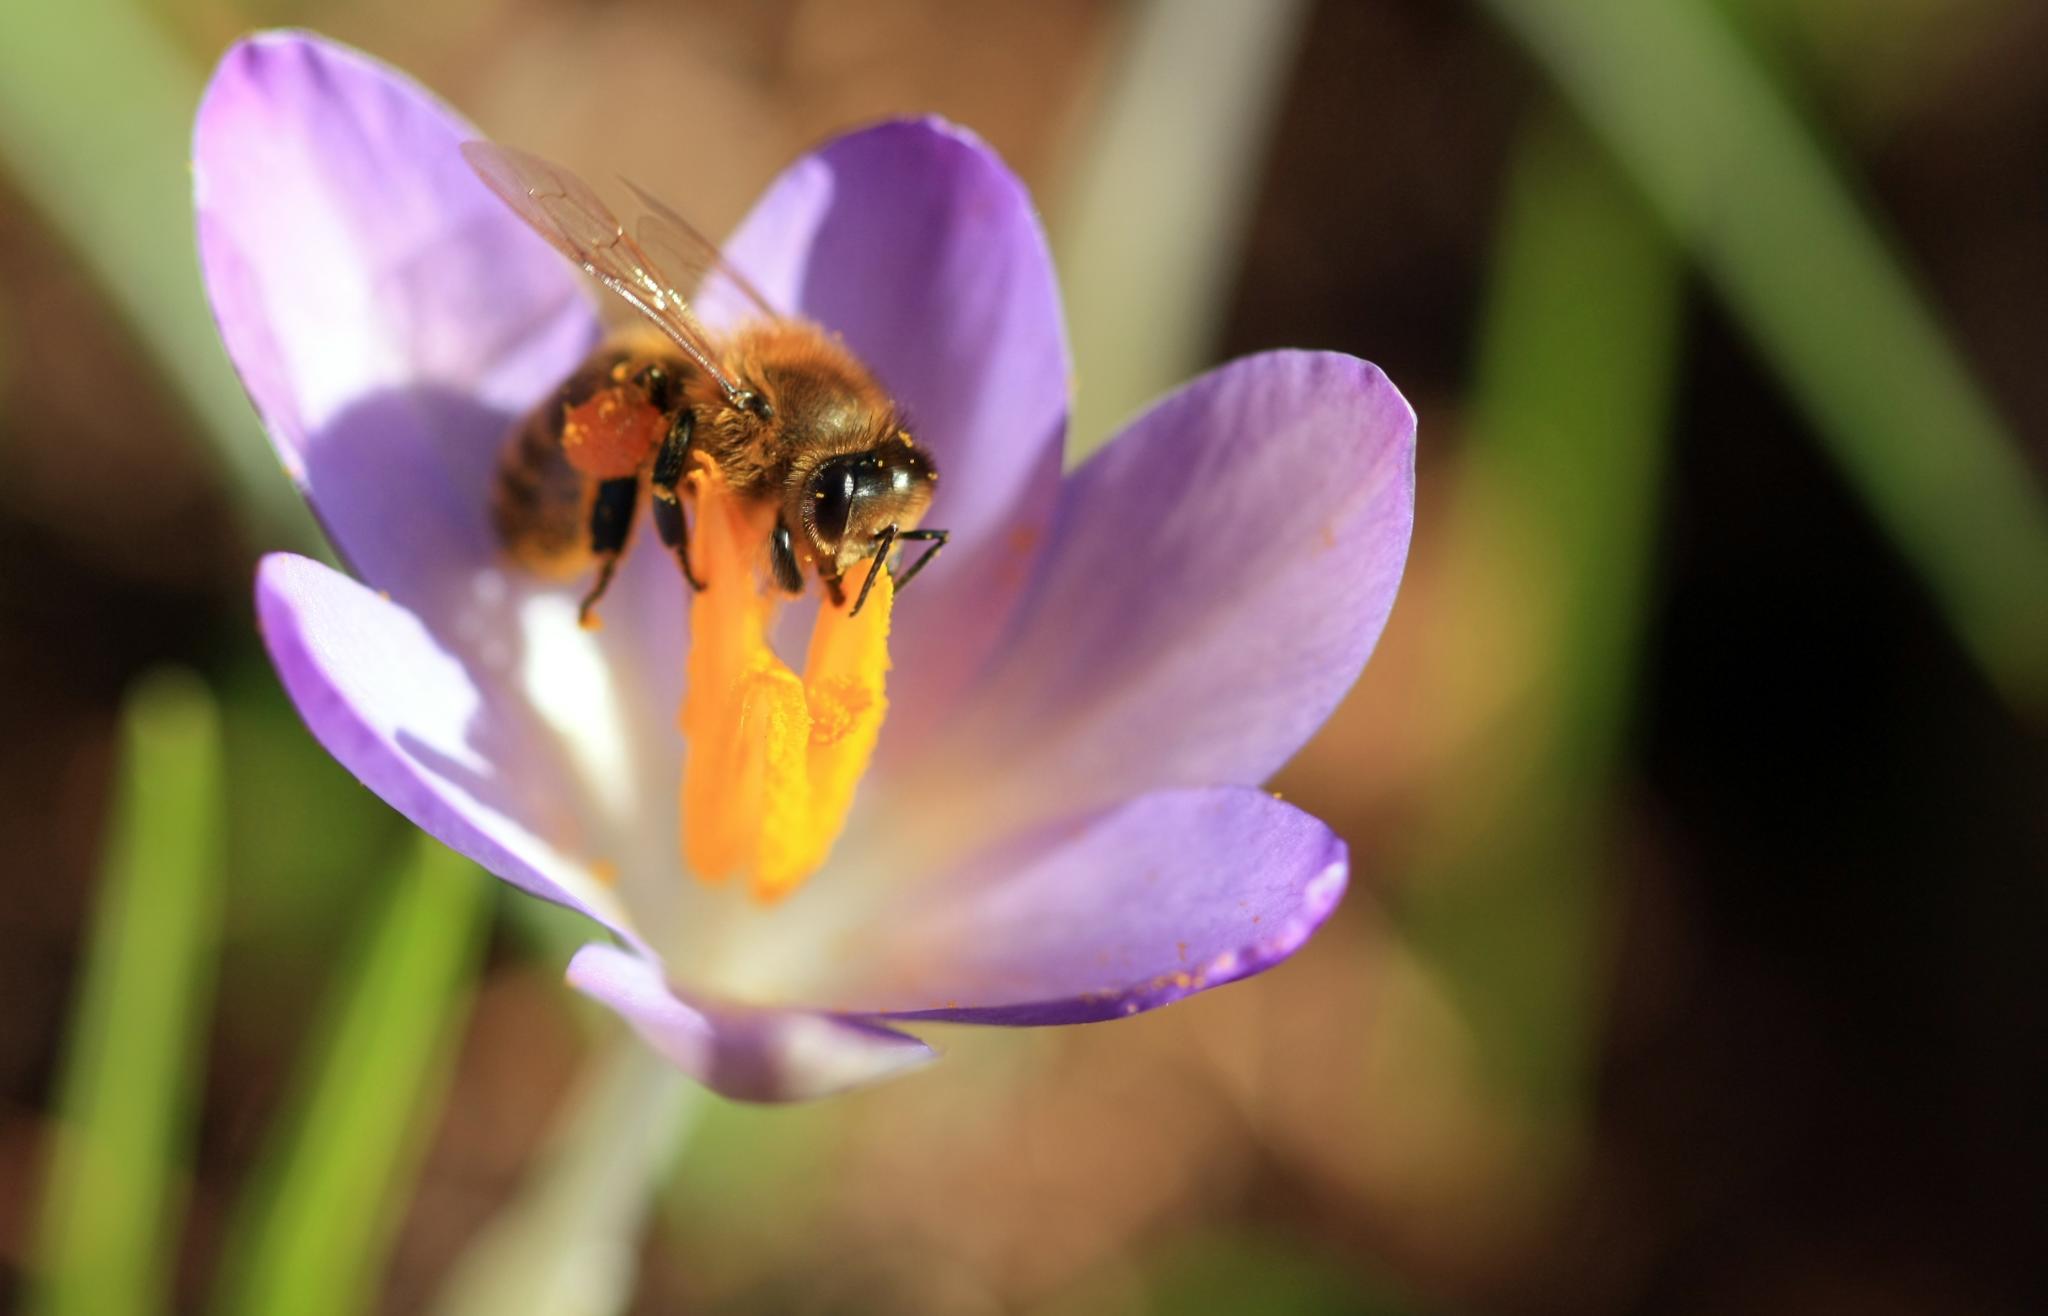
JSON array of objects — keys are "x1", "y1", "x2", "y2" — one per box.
[{"x1": 195, "y1": 35, "x2": 1415, "y2": 1101}]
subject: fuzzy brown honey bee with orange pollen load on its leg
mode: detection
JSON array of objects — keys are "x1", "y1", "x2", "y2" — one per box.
[{"x1": 463, "y1": 141, "x2": 948, "y2": 624}]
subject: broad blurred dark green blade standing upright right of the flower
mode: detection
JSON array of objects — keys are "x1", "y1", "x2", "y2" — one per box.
[{"x1": 1407, "y1": 113, "x2": 1683, "y2": 1146}]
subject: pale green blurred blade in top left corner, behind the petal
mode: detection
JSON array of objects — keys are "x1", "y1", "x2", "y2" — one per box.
[{"x1": 0, "y1": 0, "x2": 317, "y2": 544}]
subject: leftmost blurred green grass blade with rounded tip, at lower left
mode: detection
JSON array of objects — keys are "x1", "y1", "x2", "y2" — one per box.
[{"x1": 27, "y1": 673, "x2": 221, "y2": 1316}]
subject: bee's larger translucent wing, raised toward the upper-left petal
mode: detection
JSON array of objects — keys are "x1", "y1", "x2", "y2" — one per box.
[{"x1": 463, "y1": 141, "x2": 739, "y2": 397}]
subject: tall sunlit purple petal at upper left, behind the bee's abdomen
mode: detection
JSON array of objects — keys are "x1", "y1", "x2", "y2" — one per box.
[{"x1": 193, "y1": 33, "x2": 598, "y2": 606}]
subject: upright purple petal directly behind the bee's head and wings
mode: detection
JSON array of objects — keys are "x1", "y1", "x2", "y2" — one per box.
[{"x1": 727, "y1": 119, "x2": 1071, "y2": 753}]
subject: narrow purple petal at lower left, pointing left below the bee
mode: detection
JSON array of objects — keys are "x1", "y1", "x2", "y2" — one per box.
[{"x1": 256, "y1": 553, "x2": 633, "y2": 935}]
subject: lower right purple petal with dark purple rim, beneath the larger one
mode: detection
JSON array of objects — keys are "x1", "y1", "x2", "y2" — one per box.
[{"x1": 834, "y1": 788, "x2": 1350, "y2": 1025}]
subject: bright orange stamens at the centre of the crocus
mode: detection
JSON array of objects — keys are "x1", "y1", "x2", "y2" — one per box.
[{"x1": 682, "y1": 465, "x2": 895, "y2": 903}]
